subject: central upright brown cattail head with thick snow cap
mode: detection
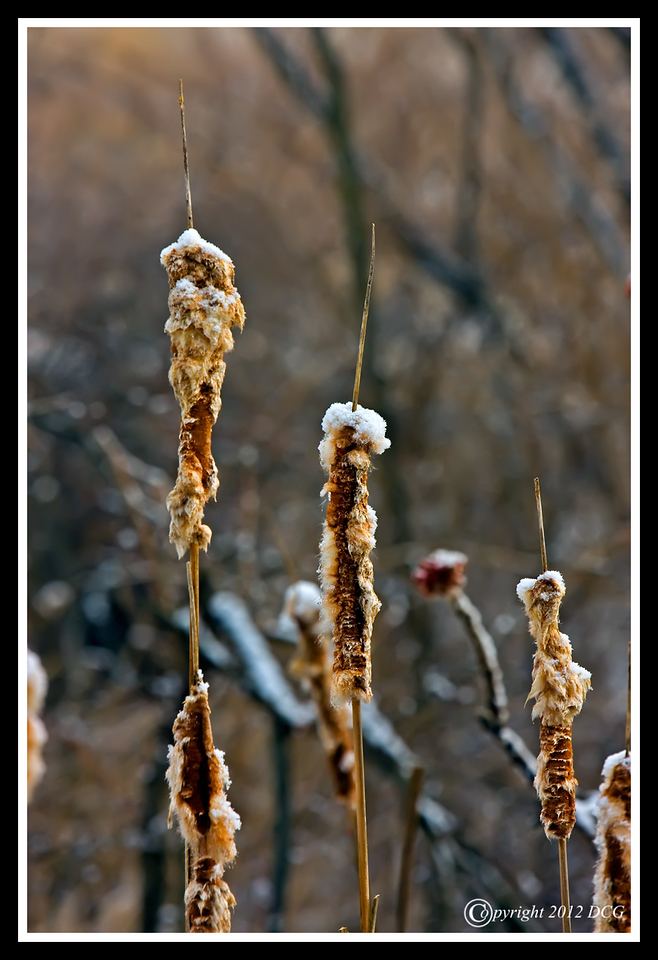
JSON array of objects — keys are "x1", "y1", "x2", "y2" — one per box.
[{"x1": 318, "y1": 403, "x2": 391, "y2": 702}]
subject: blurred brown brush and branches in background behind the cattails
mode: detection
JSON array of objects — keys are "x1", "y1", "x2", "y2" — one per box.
[{"x1": 27, "y1": 21, "x2": 630, "y2": 933}]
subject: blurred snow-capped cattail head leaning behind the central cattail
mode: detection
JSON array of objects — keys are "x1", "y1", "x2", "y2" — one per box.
[{"x1": 283, "y1": 580, "x2": 354, "y2": 807}]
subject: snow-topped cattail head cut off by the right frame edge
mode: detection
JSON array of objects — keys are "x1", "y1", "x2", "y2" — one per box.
[{"x1": 593, "y1": 752, "x2": 631, "y2": 933}]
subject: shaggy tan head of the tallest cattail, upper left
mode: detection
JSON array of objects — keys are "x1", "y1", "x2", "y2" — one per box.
[{"x1": 160, "y1": 229, "x2": 245, "y2": 558}]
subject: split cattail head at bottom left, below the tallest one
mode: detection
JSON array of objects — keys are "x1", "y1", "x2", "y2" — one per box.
[{"x1": 167, "y1": 671, "x2": 240, "y2": 933}]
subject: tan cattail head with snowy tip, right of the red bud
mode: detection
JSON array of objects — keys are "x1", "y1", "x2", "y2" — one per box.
[{"x1": 516, "y1": 570, "x2": 591, "y2": 840}]
